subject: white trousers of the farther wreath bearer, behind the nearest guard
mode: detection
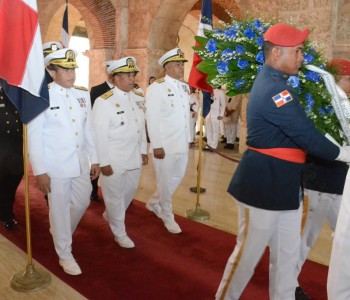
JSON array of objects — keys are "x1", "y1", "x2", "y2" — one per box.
[{"x1": 297, "y1": 189, "x2": 342, "y2": 273}]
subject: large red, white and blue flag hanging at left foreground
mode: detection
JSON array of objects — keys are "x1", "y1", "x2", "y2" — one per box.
[{"x1": 0, "y1": 0, "x2": 49, "y2": 124}]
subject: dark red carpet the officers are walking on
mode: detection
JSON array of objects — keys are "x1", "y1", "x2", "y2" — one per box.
[{"x1": 0, "y1": 172, "x2": 328, "y2": 300}]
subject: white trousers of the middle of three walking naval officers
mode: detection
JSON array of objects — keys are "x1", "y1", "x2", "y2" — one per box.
[{"x1": 100, "y1": 168, "x2": 141, "y2": 238}]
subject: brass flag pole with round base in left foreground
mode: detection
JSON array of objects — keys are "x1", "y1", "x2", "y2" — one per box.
[{"x1": 11, "y1": 124, "x2": 51, "y2": 292}]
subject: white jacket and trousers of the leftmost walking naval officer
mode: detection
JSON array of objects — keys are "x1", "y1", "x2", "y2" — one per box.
[{"x1": 28, "y1": 82, "x2": 98, "y2": 260}]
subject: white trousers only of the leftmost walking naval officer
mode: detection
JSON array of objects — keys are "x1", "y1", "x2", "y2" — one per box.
[{"x1": 48, "y1": 173, "x2": 92, "y2": 260}]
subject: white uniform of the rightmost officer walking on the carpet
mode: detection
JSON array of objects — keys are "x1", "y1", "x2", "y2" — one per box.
[{"x1": 146, "y1": 75, "x2": 191, "y2": 221}]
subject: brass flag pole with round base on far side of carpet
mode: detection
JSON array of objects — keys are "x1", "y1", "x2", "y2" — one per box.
[{"x1": 186, "y1": 105, "x2": 210, "y2": 221}]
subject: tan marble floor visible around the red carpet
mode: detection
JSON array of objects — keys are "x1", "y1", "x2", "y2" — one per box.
[{"x1": 0, "y1": 140, "x2": 331, "y2": 300}]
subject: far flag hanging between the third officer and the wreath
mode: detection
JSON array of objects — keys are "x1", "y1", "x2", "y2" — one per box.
[{"x1": 188, "y1": 0, "x2": 213, "y2": 117}]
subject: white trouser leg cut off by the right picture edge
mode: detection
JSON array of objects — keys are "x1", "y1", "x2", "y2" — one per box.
[{"x1": 327, "y1": 172, "x2": 350, "y2": 300}]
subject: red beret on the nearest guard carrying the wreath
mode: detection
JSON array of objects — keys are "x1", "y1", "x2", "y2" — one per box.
[{"x1": 264, "y1": 24, "x2": 309, "y2": 47}]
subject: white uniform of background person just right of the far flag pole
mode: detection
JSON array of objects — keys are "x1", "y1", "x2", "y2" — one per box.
[{"x1": 205, "y1": 89, "x2": 226, "y2": 149}]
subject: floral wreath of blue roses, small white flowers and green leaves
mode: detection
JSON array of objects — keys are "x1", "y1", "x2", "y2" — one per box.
[{"x1": 193, "y1": 19, "x2": 346, "y2": 144}]
